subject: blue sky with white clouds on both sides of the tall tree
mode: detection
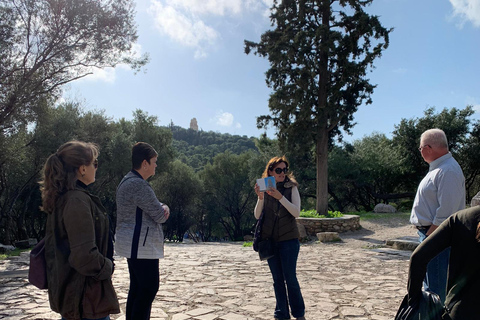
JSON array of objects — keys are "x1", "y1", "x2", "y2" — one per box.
[{"x1": 64, "y1": 0, "x2": 480, "y2": 141}]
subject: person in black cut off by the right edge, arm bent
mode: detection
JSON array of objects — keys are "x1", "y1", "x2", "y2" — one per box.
[{"x1": 408, "y1": 206, "x2": 480, "y2": 320}]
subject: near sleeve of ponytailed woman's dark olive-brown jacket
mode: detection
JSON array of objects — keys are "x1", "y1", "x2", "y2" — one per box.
[{"x1": 64, "y1": 192, "x2": 113, "y2": 281}]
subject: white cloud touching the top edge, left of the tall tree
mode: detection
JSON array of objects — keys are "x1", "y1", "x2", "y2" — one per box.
[{"x1": 149, "y1": 0, "x2": 273, "y2": 58}]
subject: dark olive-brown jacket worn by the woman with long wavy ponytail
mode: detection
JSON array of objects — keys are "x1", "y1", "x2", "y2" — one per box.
[{"x1": 45, "y1": 182, "x2": 120, "y2": 319}]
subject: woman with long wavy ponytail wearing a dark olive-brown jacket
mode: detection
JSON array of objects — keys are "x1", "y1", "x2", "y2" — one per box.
[{"x1": 40, "y1": 141, "x2": 120, "y2": 320}]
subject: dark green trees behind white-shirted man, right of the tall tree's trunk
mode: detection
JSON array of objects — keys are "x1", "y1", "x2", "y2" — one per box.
[{"x1": 328, "y1": 106, "x2": 480, "y2": 212}]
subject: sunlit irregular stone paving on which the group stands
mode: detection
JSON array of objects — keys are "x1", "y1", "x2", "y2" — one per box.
[{"x1": 0, "y1": 243, "x2": 410, "y2": 320}]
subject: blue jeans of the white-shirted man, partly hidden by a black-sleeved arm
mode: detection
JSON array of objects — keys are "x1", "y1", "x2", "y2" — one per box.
[{"x1": 417, "y1": 230, "x2": 450, "y2": 303}]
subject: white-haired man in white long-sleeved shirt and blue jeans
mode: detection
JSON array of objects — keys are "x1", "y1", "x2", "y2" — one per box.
[{"x1": 410, "y1": 129, "x2": 465, "y2": 302}]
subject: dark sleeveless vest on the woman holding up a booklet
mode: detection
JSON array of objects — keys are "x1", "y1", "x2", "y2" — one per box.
[{"x1": 262, "y1": 178, "x2": 300, "y2": 242}]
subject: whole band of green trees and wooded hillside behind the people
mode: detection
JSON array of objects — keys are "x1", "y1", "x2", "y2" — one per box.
[{"x1": 0, "y1": 72, "x2": 480, "y2": 244}]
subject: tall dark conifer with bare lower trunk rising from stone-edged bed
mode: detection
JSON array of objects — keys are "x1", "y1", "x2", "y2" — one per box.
[{"x1": 245, "y1": 0, "x2": 391, "y2": 212}]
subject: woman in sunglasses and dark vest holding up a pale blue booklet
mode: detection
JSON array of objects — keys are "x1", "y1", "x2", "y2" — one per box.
[{"x1": 255, "y1": 157, "x2": 305, "y2": 320}]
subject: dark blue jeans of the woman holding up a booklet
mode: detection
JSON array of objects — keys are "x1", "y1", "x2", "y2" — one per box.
[{"x1": 267, "y1": 239, "x2": 305, "y2": 319}]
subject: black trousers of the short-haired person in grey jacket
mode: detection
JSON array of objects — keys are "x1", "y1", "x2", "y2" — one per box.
[{"x1": 125, "y1": 259, "x2": 160, "y2": 320}]
